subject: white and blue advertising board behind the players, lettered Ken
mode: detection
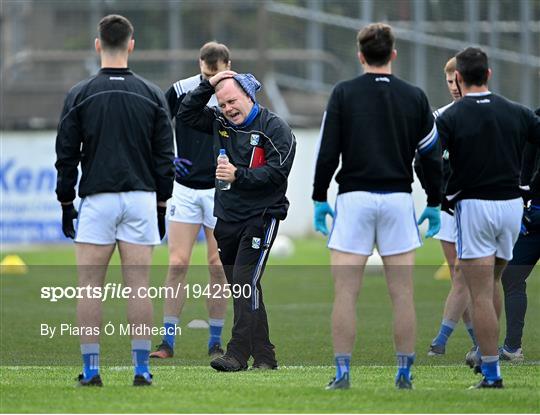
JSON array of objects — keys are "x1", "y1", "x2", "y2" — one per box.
[{"x1": 0, "y1": 130, "x2": 426, "y2": 244}]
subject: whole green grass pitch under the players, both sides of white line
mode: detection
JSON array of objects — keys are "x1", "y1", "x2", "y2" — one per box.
[{"x1": 0, "y1": 239, "x2": 540, "y2": 413}]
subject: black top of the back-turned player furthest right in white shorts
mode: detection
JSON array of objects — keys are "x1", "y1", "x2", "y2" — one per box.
[{"x1": 436, "y1": 93, "x2": 540, "y2": 202}]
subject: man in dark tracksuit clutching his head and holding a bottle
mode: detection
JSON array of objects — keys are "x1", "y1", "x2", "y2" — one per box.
[{"x1": 178, "y1": 71, "x2": 296, "y2": 372}]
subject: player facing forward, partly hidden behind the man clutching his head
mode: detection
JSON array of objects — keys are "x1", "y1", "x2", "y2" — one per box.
[{"x1": 150, "y1": 42, "x2": 231, "y2": 358}]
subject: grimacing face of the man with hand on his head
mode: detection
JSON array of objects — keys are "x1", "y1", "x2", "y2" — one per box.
[{"x1": 216, "y1": 78, "x2": 253, "y2": 125}]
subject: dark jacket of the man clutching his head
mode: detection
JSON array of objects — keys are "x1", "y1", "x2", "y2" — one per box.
[{"x1": 178, "y1": 80, "x2": 296, "y2": 222}]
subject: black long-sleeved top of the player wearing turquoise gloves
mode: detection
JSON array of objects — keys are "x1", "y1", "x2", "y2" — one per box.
[{"x1": 312, "y1": 73, "x2": 442, "y2": 206}]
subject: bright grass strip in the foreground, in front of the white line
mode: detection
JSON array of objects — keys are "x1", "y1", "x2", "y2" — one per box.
[{"x1": 0, "y1": 366, "x2": 539, "y2": 413}]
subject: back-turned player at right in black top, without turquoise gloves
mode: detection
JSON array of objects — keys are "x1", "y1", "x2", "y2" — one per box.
[{"x1": 437, "y1": 48, "x2": 540, "y2": 388}]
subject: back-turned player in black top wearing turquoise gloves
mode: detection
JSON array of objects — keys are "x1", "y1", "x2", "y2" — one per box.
[{"x1": 312, "y1": 23, "x2": 442, "y2": 389}]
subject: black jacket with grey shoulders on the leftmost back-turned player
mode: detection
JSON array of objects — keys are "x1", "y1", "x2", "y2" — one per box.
[{"x1": 55, "y1": 68, "x2": 174, "y2": 203}]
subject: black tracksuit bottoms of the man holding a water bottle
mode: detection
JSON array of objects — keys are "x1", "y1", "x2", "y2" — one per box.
[{"x1": 214, "y1": 216, "x2": 279, "y2": 366}]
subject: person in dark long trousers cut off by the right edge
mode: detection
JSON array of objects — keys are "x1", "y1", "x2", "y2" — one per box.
[{"x1": 499, "y1": 108, "x2": 540, "y2": 361}]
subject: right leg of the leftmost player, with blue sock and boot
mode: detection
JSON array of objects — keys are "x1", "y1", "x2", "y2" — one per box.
[{"x1": 118, "y1": 241, "x2": 153, "y2": 386}]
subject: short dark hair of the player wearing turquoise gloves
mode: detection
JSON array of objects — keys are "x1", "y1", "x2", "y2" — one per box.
[{"x1": 356, "y1": 23, "x2": 396, "y2": 66}]
